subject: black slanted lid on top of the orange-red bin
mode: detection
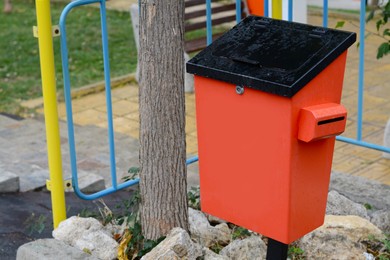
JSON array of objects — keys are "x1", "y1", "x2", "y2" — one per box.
[{"x1": 187, "y1": 16, "x2": 356, "y2": 97}]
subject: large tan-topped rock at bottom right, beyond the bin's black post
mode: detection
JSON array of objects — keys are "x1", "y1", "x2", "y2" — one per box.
[{"x1": 297, "y1": 215, "x2": 383, "y2": 260}]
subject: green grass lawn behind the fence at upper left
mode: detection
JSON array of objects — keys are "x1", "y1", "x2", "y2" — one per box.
[{"x1": 0, "y1": 0, "x2": 137, "y2": 114}]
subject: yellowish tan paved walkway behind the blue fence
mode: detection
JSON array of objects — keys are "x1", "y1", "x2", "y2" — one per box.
[{"x1": 22, "y1": 8, "x2": 390, "y2": 184}]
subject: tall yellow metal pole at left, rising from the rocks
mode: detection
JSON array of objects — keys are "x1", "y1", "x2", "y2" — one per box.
[{"x1": 35, "y1": 0, "x2": 66, "y2": 228}]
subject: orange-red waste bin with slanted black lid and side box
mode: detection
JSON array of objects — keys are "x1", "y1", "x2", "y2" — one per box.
[{"x1": 187, "y1": 16, "x2": 356, "y2": 244}]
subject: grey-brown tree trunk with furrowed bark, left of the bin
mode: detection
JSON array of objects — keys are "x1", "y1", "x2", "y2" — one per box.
[{"x1": 138, "y1": 0, "x2": 188, "y2": 239}]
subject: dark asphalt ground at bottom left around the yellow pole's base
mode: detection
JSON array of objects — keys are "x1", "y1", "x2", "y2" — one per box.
[{"x1": 0, "y1": 191, "x2": 131, "y2": 260}]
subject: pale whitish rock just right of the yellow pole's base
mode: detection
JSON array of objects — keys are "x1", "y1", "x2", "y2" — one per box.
[{"x1": 53, "y1": 216, "x2": 118, "y2": 259}]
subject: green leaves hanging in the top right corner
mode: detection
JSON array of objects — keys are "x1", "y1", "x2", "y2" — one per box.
[{"x1": 366, "y1": 0, "x2": 390, "y2": 59}]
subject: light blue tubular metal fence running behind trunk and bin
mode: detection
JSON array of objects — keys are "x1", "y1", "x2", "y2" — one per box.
[{"x1": 60, "y1": 0, "x2": 390, "y2": 200}]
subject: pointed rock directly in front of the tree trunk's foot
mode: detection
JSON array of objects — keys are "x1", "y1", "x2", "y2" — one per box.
[{"x1": 141, "y1": 228, "x2": 202, "y2": 260}]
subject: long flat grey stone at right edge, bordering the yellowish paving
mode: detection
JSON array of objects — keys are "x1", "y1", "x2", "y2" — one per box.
[{"x1": 330, "y1": 172, "x2": 390, "y2": 210}]
